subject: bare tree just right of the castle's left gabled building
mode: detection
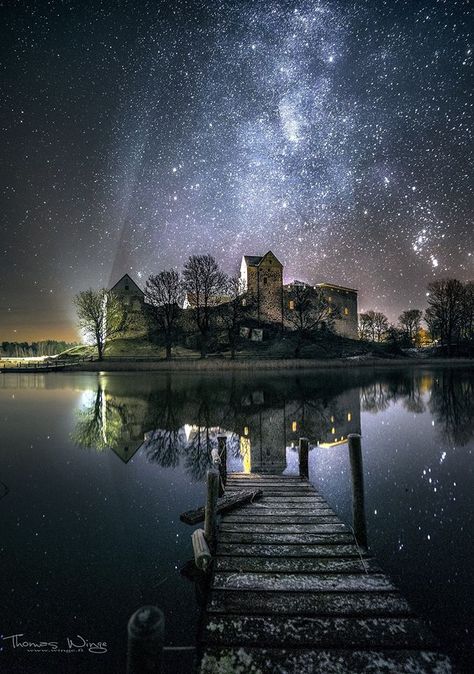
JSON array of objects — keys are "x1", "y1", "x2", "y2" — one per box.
[{"x1": 145, "y1": 269, "x2": 184, "y2": 359}]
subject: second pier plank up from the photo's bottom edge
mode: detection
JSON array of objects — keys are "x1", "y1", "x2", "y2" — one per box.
[{"x1": 203, "y1": 615, "x2": 435, "y2": 648}]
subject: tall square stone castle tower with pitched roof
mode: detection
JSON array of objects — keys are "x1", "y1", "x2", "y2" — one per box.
[{"x1": 240, "y1": 250, "x2": 283, "y2": 324}]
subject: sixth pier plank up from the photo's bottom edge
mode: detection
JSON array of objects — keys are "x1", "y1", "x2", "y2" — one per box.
[{"x1": 217, "y1": 537, "x2": 366, "y2": 559}]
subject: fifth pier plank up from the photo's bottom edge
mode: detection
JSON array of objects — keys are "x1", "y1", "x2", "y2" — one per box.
[{"x1": 215, "y1": 555, "x2": 381, "y2": 573}]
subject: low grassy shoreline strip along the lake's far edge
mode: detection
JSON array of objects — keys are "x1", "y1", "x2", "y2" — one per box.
[{"x1": 53, "y1": 358, "x2": 474, "y2": 372}]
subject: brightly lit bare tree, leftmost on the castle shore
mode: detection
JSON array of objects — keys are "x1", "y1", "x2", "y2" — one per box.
[{"x1": 74, "y1": 288, "x2": 126, "y2": 360}]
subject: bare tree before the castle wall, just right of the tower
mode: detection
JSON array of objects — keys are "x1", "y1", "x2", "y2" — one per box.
[{"x1": 285, "y1": 284, "x2": 339, "y2": 358}]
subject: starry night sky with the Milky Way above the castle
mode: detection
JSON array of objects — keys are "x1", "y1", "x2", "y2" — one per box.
[{"x1": 0, "y1": 0, "x2": 474, "y2": 340}]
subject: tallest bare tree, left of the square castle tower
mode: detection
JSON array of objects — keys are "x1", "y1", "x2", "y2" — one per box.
[{"x1": 183, "y1": 255, "x2": 226, "y2": 358}]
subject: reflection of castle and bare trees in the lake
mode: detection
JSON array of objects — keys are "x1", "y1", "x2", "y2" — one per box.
[{"x1": 68, "y1": 370, "x2": 473, "y2": 479}]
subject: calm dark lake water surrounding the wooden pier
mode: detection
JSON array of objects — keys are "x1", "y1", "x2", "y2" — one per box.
[{"x1": 0, "y1": 368, "x2": 474, "y2": 674}]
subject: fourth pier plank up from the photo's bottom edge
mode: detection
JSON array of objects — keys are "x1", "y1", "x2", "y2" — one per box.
[{"x1": 213, "y1": 571, "x2": 395, "y2": 592}]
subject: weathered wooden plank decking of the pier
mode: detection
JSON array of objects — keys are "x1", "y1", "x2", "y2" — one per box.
[{"x1": 201, "y1": 473, "x2": 452, "y2": 674}]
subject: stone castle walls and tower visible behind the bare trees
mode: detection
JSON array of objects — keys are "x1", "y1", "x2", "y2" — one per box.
[{"x1": 111, "y1": 250, "x2": 358, "y2": 339}]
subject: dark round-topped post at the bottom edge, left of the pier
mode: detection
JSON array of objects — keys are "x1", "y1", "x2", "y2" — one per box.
[{"x1": 127, "y1": 606, "x2": 165, "y2": 674}]
